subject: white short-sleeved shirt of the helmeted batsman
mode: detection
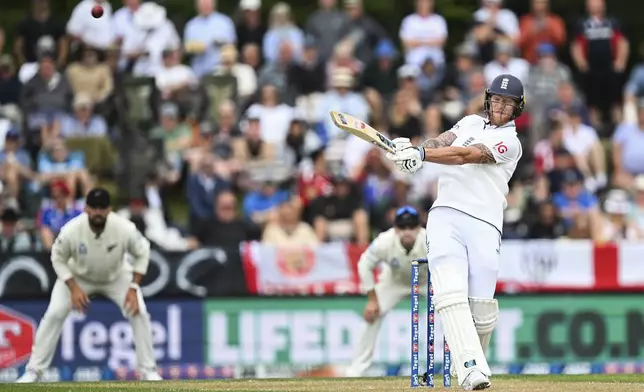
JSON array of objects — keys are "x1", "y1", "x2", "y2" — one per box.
[{"x1": 432, "y1": 114, "x2": 523, "y2": 232}]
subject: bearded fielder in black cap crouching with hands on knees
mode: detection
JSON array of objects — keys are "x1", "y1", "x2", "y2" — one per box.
[{"x1": 18, "y1": 188, "x2": 161, "y2": 383}]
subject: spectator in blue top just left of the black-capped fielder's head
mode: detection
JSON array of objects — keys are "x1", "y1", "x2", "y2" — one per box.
[{"x1": 38, "y1": 180, "x2": 83, "y2": 251}]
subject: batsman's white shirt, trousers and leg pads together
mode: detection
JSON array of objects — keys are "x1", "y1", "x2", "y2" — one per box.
[{"x1": 427, "y1": 115, "x2": 522, "y2": 382}]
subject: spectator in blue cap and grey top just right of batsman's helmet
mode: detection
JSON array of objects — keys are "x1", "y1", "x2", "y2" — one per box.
[{"x1": 526, "y1": 43, "x2": 572, "y2": 146}]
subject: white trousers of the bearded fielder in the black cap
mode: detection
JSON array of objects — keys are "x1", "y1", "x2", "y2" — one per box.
[{"x1": 27, "y1": 272, "x2": 156, "y2": 372}]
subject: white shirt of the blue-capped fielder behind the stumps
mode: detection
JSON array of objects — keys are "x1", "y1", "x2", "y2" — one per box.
[{"x1": 358, "y1": 227, "x2": 427, "y2": 291}]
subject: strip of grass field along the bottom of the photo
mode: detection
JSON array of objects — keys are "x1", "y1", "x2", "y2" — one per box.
[{"x1": 0, "y1": 375, "x2": 644, "y2": 392}]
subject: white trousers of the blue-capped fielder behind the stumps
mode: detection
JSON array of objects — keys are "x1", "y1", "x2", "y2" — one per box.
[{"x1": 346, "y1": 275, "x2": 427, "y2": 377}]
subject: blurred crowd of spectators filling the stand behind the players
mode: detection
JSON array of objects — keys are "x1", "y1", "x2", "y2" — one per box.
[{"x1": 0, "y1": 0, "x2": 644, "y2": 254}]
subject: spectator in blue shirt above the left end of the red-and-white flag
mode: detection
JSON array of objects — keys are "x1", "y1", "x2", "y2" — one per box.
[{"x1": 244, "y1": 179, "x2": 290, "y2": 225}]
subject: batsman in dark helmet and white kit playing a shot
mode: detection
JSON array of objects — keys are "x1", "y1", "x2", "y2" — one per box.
[{"x1": 387, "y1": 74, "x2": 525, "y2": 390}]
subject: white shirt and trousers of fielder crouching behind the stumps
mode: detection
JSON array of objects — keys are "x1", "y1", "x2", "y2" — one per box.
[{"x1": 347, "y1": 228, "x2": 427, "y2": 377}]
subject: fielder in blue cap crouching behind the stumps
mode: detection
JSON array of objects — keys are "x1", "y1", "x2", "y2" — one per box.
[{"x1": 347, "y1": 207, "x2": 427, "y2": 377}]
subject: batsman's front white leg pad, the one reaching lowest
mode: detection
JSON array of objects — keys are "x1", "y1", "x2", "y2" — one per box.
[{"x1": 431, "y1": 263, "x2": 491, "y2": 382}]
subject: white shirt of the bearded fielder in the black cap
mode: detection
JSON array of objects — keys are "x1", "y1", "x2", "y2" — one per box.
[{"x1": 51, "y1": 212, "x2": 150, "y2": 283}]
